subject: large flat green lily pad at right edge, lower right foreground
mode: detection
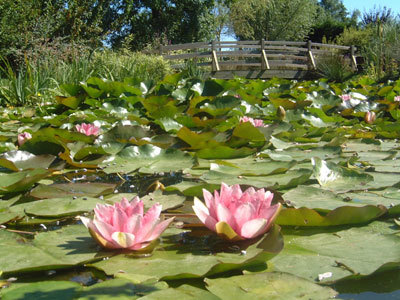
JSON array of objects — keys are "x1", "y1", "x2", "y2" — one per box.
[{"x1": 268, "y1": 221, "x2": 400, "y2": 282}]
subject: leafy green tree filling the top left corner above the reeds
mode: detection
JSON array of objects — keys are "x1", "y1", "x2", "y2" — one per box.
[{"x1": 0, "y1": 0, "x2": 119, "y2": 66}]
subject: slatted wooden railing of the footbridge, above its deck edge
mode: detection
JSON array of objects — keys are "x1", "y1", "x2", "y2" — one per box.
[{"x1": 159, "y1": 40, "x2": 357, "y2": 78}]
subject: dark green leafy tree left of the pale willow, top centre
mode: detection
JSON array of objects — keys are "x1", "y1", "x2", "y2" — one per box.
[{"x1": 110, "y1": 0, "x2": 214, "y2": 50}]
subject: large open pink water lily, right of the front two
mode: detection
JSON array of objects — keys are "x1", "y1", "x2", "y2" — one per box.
[{"x1": 193, "y1": 183, "x2": 281, "y2": 241}]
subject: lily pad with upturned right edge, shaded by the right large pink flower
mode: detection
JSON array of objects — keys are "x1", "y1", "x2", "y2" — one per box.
[{"x1": 93, "y1": 226, "x2": 282, "y2": 280}]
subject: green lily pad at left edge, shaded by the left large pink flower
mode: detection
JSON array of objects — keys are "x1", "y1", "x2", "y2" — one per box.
[{"x1": 0, "y1": 225, "x2": 110, "y2": 275}]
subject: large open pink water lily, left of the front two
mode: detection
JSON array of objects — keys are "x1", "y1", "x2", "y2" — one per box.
[{"x1": 80, "y1": 197, "x2": 174, "y2": 250}]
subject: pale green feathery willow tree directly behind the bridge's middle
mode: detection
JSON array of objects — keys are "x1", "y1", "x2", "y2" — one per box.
[{"x1": 231, "y1": 0, "x2": 317, "y2": 41}]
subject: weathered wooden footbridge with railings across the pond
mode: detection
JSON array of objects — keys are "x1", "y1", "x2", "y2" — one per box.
[{"x1": 159, "y1": 40, "x2": 357, "y2": 78}]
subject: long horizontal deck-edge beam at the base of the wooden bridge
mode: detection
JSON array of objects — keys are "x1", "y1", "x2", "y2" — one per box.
[{"x1": 207, "y1": 70, "x2": 309, "y2": 79}]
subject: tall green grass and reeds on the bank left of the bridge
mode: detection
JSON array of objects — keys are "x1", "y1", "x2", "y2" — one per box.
[{"x1": 0, "y1": 50, "x2": 171, "y2": 106}]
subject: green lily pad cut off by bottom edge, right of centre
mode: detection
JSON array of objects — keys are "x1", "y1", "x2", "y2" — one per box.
[{"x1": 205, "y1": 272, "x2": 337, "y2": 300}]
